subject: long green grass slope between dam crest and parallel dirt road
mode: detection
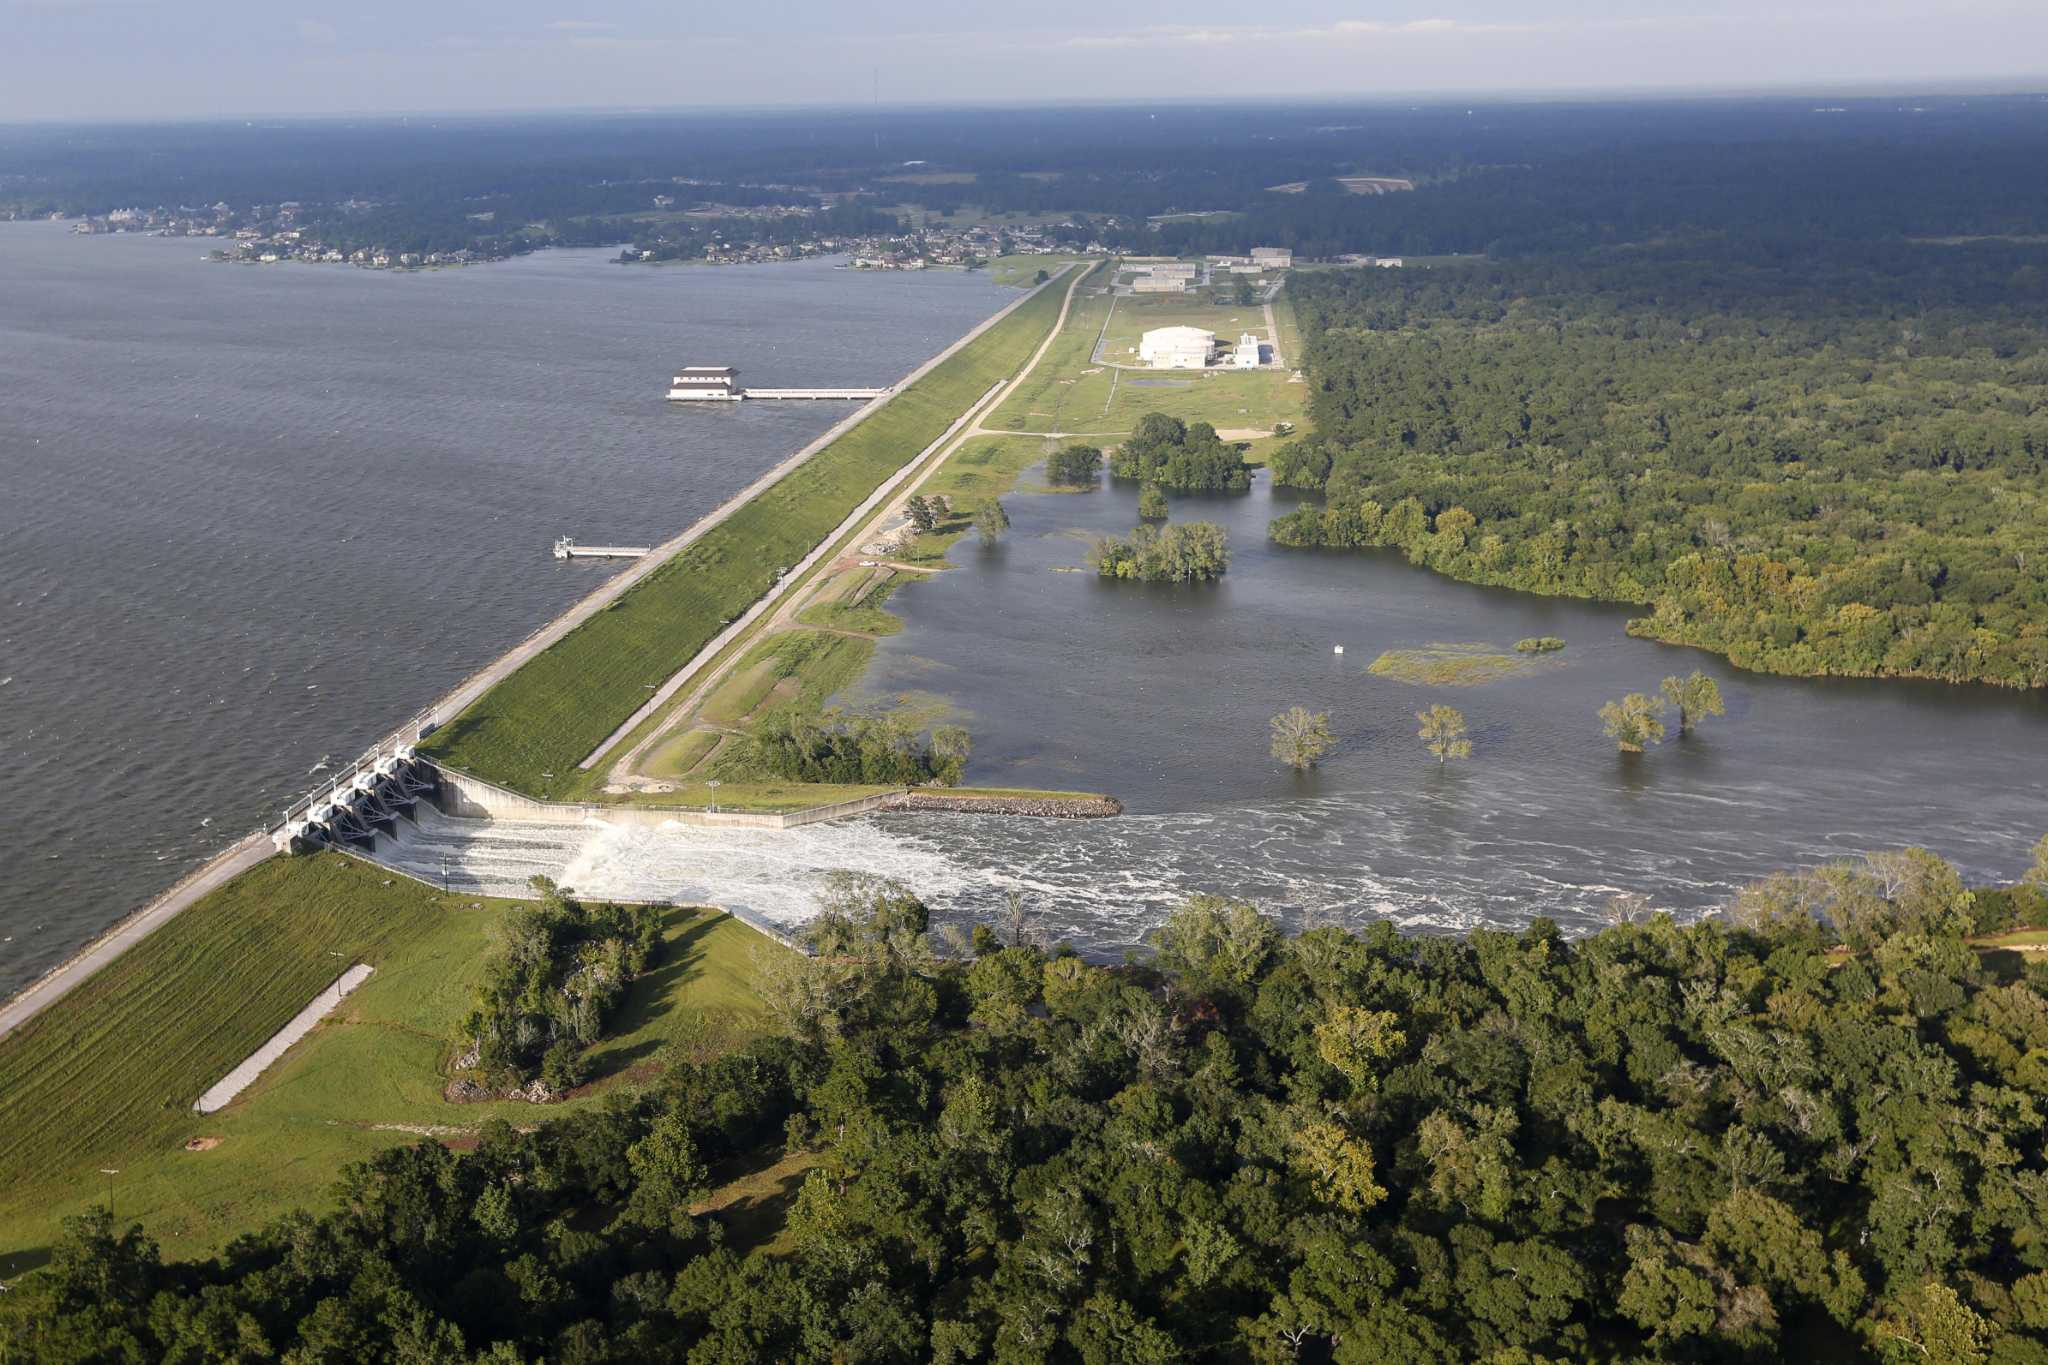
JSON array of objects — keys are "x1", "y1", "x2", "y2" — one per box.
[{"x1": 424, "y1": 278, "x2": 1065, "y2": 798}]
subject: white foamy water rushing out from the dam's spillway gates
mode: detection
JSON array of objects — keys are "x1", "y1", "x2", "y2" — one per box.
[{"x1": 375, "y1": 798, "x2": 1735, "y2": 958}]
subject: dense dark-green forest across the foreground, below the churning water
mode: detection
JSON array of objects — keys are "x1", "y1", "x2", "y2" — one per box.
[{"x1": 12, "y1": 855, "x2": 2048, "y2": 1365}]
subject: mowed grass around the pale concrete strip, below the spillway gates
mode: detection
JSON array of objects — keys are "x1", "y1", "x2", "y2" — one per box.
[{"x1": 0, "y1": 853, "x2": 786, "y2": 1279}]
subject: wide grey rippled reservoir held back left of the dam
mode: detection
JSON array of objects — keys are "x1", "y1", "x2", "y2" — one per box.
[{"x1": 0, "y1": 223, "x2": 1016, "y2": 993}]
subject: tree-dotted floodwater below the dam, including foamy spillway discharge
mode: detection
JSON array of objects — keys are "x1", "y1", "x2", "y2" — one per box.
[{"x1": 372, "y1": 464, "x2": 2048, "y2": 956}]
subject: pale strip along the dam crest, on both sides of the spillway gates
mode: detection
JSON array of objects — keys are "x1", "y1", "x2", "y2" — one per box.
[{"x1": 0, "y1": 272, "x2": 1065, "y2": 1040}]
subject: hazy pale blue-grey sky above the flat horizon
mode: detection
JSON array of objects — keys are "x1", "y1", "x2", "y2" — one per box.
[{"x1": 0, "y1": 0, "x2": 2048, "y2": 121}]
